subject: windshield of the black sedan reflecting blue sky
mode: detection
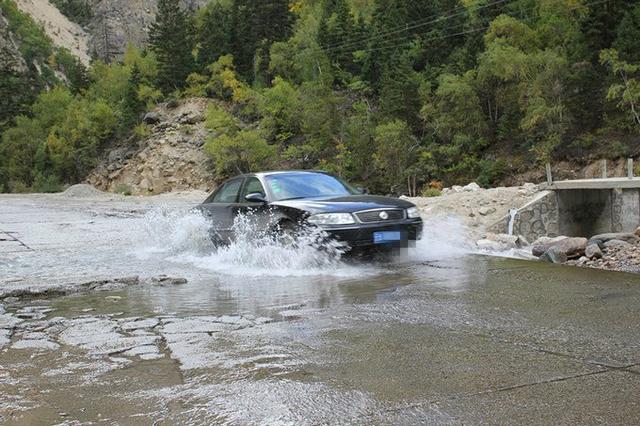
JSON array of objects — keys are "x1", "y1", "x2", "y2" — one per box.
[{"x1": 265, "y1": 173, "x2": 360, "y2": 201}]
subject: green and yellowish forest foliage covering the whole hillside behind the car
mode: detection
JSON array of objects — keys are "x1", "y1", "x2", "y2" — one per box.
[{"x1": 0, "y1": 0, "x2": 640, "y2": 194}]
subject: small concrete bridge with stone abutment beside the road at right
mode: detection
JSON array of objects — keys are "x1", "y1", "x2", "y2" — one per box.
[{"x1": 489, "y1": 175, "x2": 640, "y2": 242}]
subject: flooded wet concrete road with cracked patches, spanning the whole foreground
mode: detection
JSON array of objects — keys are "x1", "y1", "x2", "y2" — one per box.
[{"x1": 0, "y1": 197, "x2": 640, "y2": 425}]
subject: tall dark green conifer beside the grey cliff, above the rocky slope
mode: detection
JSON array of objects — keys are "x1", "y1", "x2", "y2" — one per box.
[{"x1": 149, "y1": 0, "x2": 194, "y2": 93}]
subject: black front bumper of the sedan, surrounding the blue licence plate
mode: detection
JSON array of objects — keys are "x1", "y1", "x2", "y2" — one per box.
[{"x1": 322, "y1": 219, "x2": 422, "y2": 248}]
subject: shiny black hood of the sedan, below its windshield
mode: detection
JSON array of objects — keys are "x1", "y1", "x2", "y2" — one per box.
[{"x1": 272, "y1": 195, "x2": 415, "y2": 214}]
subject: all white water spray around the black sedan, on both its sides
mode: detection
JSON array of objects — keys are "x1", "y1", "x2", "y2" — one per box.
[{"x1": 141, "y1": 211, "x2": 472, "y2": 277}]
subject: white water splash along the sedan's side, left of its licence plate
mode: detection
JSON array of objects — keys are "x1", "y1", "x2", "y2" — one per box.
[{"x1": 142, "y1": 211, "x2": 362, "y2": 276}]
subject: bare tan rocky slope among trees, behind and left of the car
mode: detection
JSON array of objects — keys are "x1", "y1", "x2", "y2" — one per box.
[{"x1": 87, "y1": 98, "x2": 215, "y2": 195}]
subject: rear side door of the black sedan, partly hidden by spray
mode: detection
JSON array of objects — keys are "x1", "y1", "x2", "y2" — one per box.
[{"x1": 201, "y1": 178, "x2": 244, "y2": 241}]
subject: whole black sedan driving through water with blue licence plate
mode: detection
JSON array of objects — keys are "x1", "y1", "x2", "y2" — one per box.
[{"x1": 199, "y1": 171, "x2": 422, "y2": 248}]
